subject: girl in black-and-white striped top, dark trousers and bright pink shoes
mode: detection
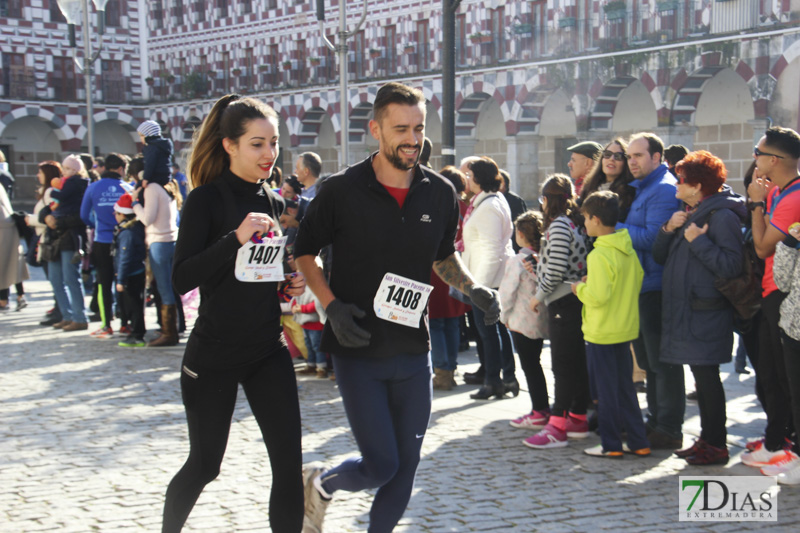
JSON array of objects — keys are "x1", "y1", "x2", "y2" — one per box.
[{"x1": 524, "y1": 174, "x2": 589, "y2": 448}]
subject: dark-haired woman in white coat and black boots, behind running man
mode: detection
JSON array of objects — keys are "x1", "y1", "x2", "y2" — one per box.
[{"x1": 463, "y1": 157, "x2": 519, "y2": 400}]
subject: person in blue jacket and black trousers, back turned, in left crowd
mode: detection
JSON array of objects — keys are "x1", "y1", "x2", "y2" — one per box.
[{"x1": 81, "y1": 154, "x2": 131, "y2": 338}]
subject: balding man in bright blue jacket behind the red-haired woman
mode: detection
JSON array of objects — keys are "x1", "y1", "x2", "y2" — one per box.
[{"x1": 617, "y1": 133, "x2": 686, "y2": 450}]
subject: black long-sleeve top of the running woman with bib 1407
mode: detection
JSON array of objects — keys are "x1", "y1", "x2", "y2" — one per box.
[{"x1": 172, "y1": 170, "x2": 285, "y2": 368}]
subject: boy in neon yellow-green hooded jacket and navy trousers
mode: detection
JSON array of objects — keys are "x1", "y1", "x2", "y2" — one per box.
[{"x1": 572, "y1": 191, "x2": 650, "y2": 458}]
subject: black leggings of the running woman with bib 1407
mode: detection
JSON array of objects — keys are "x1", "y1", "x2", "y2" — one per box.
[{"x1": 162, "y1": 339, "x2": 303, "y2": 533}]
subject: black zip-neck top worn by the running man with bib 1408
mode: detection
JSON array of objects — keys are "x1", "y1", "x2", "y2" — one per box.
[{"x1": 295, "y1": 154, "x2": 459, "y2": 357}]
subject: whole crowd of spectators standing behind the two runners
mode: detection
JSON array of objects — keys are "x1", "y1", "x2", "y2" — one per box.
[{"x1": 0, "y1": 116, "x2": 800, "y2": 490}]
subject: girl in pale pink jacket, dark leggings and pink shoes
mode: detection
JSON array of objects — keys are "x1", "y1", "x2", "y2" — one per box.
[{"x1": 500, "y1": 211, "x2": 550, "y2": 430}]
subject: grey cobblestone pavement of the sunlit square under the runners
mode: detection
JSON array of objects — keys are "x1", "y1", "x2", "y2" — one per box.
[{"x1": 0, "y1": 274, "x2": 800, "y2": 533}]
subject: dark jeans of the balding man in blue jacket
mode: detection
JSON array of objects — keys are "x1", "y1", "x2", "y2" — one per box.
[{"x1": 633, "y1": 291, "x2": 686, "y2": 438}]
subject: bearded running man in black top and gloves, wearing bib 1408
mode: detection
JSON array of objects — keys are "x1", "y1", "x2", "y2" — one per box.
[{"x1": 295, "y1": 83, "x2": 500, "y2": 533}]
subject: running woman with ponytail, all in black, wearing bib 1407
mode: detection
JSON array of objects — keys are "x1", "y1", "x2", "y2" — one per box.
[{"x1": 162, "y1": 95, "x2": 305, "y2": 533}]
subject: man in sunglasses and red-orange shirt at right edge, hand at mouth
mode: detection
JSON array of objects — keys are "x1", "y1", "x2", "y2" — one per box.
[{"x1": 742, "y1": 127, "x2": 800, "y2": 476}]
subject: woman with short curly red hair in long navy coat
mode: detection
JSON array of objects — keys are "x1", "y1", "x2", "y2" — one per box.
[{"x1": 653, "y1": 150, "x2": 747, "y2": 465}]
